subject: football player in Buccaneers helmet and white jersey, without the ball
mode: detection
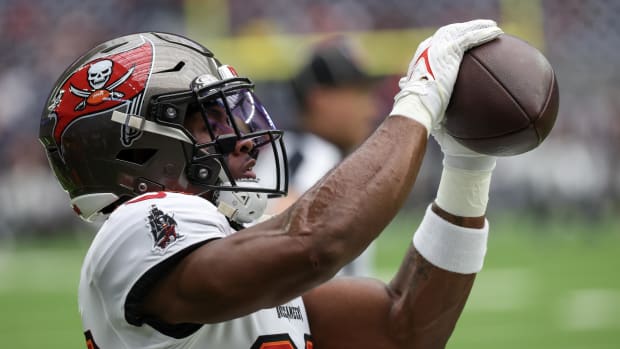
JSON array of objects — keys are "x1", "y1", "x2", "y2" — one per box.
[{"x1": 40, "y1": 20, "x2": 501, "y2": 349}]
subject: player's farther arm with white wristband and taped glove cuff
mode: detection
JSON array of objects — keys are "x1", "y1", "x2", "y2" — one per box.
[{"x1": 304, "y1": 19, "x2": 504, "y2": 349}]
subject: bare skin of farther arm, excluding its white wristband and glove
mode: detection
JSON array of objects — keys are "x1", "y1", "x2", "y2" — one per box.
[{"x1": 304, "y1": 204, "x2": 485, "y2": 349}]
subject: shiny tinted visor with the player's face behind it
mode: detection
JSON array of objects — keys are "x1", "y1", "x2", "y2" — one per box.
[{"x1": 185, "y1": 88, "x2": 287, "y2": 196}]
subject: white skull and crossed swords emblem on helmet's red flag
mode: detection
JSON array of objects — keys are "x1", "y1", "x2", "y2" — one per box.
[{"x1": 69, "y1": 59, "x2": 135, "y2": 111}]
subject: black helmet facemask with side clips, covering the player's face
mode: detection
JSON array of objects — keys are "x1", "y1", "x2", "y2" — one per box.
[{"x1": 151, "y1": 74, "x2": 288, "y2": 209}]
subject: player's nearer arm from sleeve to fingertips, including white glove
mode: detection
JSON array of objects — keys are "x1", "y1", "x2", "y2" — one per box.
[{"x1": 144, "y1": 21, "x2": 501, "y2": 332}]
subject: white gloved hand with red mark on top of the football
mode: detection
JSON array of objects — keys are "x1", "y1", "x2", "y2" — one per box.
[{"x1": 390, "y1": 20, "x2": 502, "y2": 134}]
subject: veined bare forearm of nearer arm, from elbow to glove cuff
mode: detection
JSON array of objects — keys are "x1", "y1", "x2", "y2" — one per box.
[{"x1": 286, "y1": 116, "x2": 427, "y2": 272}]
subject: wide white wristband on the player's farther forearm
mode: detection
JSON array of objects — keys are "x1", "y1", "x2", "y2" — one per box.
[{"x1": 413, "y1": 206, "x2": 489, "y2": 274}]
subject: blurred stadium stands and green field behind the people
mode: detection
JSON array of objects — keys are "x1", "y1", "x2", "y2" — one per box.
[{"x1": 0, "y1": 0, "x2": 620, "y2": 349}]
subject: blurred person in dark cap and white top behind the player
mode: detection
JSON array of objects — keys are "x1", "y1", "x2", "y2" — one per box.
[{"x1": 273, "y1": 37, "x2": 380, "y2": 276}]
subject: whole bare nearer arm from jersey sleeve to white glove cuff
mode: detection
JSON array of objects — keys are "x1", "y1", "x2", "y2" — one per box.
[{"x1": 147, "y1": 116, "x2": 427, "y2": 323}]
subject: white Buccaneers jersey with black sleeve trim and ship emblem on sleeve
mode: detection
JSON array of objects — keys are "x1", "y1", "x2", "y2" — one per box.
[{"x1": 79, "y1": 192, "x2": 312, "y2": 349}]
